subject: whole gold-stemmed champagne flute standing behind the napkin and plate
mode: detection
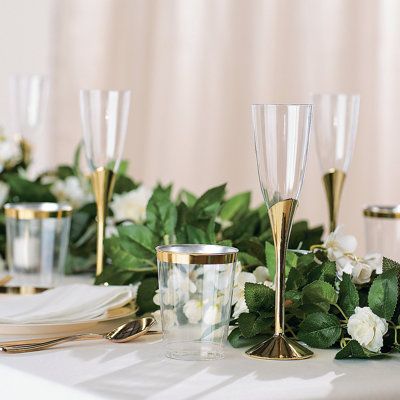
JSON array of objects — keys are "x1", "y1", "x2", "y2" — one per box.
[{"x1": 80, "y1": 90, "x2": 131, "y2": 275}]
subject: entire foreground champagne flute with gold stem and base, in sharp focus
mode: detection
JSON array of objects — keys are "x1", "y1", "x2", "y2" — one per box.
[{"x1": 246, "y1": 104, "x2": 313, "y2": 360}]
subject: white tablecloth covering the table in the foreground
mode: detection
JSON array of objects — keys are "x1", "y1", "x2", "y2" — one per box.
[{"x1": 0, "y1": 336, "x2": 400, "y2": 400}]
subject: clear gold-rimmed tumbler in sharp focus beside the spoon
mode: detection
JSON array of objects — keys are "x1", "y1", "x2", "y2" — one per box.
[{"x1": 157, "y1": 244, "x2": 238, "y2": 360}]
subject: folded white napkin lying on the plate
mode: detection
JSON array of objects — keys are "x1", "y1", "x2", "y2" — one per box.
[{"x1": 0, "y1": 284, "x2": 134, "y2": 324}]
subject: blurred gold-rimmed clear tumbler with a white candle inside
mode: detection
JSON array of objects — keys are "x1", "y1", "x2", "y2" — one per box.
[{"x1": 4, "y1": 203, "x2": 72, "y2": 287}]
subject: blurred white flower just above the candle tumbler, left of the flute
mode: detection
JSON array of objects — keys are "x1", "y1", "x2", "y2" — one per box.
[{"x1": 51, "y1": 176, "x2": 93, "y2": 208}]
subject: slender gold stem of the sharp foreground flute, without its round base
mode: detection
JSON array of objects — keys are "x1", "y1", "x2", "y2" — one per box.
[{"x1": 268, "y1": 199, "x2": 297, "y2": 336}]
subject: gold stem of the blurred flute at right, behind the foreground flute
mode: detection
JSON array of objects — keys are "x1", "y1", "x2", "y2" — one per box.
[{"x1": 322, "y1": 169, "x2": 346, "y2": 232}]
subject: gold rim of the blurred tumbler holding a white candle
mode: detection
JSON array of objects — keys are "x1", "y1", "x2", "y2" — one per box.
[{"x1": 4, "y1": 203, "x2": 72, "y2": 219}]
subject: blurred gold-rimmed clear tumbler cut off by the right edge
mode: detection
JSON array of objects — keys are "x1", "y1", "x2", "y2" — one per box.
[{"x1": 363, "y1": 205, "x2": 400, "y2": 261}]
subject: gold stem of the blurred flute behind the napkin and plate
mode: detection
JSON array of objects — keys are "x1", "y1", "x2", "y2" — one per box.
[{"x1": 92, "y1": 167, "x2": 115, "y2": 276}]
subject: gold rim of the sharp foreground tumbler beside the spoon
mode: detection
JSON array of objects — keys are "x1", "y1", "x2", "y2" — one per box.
[{"x1": 156, "y1": 244, "x2": 239, "y2": 264}]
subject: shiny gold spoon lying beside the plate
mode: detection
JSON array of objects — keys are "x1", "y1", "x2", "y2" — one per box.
[{"x1": 0, "y1": 317, "x2": 155, "y2": 353}]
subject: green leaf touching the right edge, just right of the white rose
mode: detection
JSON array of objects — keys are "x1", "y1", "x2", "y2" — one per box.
[{"x1": 368, "y1": 270, "x2": 398, "y2": 320}]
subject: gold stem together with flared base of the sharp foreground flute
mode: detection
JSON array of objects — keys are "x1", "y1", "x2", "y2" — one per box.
[{"x1": 246, "y1": 199, "x2": 313, "y2": 360}]
